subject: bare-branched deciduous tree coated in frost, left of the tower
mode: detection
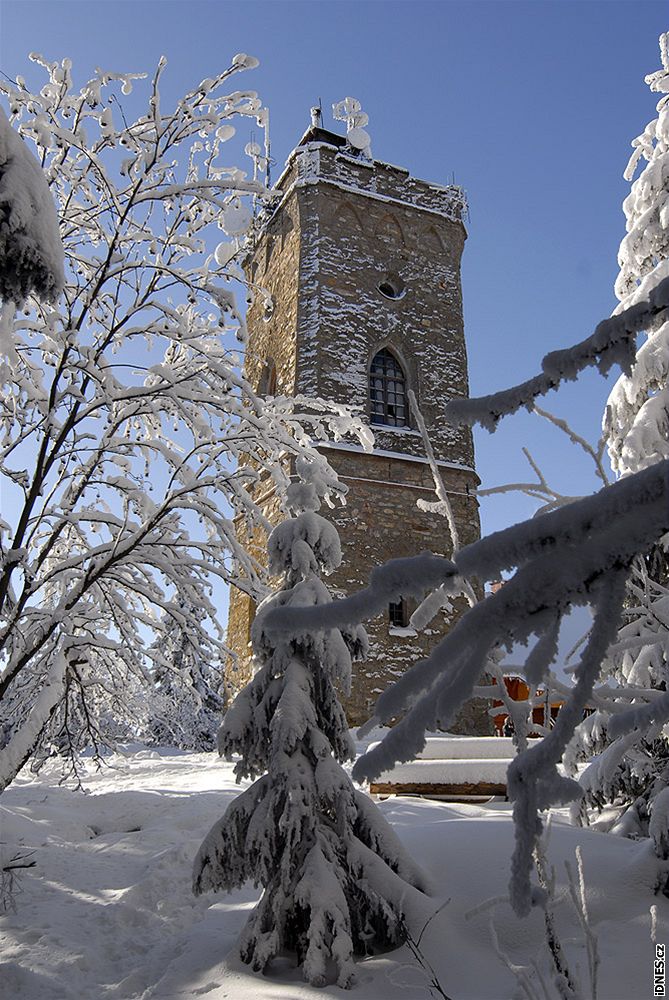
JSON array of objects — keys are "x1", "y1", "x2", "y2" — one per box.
[{"x1": 0, "y1": 54, "x2": 366, "y2": 789}]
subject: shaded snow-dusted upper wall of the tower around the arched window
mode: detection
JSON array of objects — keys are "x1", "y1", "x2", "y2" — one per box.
[{"x1": 293, "y1": 146, "x2": 474, "y2": 466}]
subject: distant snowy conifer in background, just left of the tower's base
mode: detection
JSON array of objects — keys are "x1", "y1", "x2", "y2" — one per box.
[{"x1": 147, "y1": 602, "x2": 225, "y2": 750}]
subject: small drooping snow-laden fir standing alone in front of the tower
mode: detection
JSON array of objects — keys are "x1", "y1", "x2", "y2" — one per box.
[{"x1": 194, "y1": 457, "x2": 425, "y2": 987}]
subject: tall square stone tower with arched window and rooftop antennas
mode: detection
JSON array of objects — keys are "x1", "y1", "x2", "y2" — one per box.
[{"x1": 228, "y1": 113, "x2": 492, "y2": 734}]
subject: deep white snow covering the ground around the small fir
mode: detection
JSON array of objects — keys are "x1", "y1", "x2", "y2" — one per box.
[{"x1": 0, "y1": 749, "x2": 669, "y2": 1000}]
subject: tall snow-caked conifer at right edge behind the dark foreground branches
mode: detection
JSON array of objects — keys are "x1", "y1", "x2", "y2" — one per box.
[{"x1": 568, "y1": 34, "x2": 669, "y2": 857}]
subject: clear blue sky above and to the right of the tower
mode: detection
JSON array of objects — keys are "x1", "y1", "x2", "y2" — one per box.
[{"x1": 0, "y1": 0, "x2": 669, "y2": 531}]
